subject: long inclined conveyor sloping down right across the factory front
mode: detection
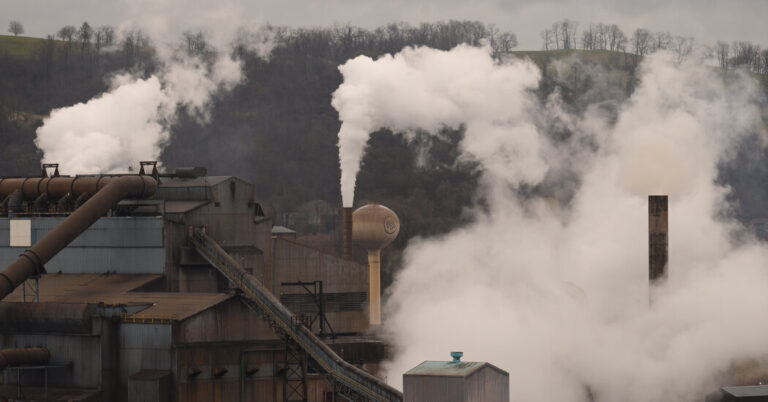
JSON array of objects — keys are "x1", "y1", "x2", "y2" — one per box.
[{"x1": 189, "y1": 228, "x2": 403, "y2": 402}]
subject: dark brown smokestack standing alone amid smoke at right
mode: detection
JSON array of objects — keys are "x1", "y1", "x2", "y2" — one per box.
[{"x1": 648, "y1": 195, "x2": 669, "y2": 285}]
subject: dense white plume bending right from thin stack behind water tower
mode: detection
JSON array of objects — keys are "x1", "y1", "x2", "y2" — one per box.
[{"x1": 332, "y1": 45, "x2": 546, "y2": 207}]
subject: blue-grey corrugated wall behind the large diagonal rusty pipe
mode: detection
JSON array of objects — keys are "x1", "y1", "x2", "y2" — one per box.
[{"x1": 0, "y1": 217, "x2": 165, "y2": 274}]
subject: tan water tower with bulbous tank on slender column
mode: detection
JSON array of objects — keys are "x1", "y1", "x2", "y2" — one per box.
[{"x1": 352, "y1": 203, "x2": 400, "y2": 325}]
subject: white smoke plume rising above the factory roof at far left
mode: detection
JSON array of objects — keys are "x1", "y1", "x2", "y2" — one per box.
[{"x1": 35, "y1": 34, "x2": 242, "y2": 173}]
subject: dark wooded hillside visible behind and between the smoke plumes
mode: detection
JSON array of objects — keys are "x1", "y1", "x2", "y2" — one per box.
[{"x1": 0, "y1": 30, "x2": 768, "y2": 283}]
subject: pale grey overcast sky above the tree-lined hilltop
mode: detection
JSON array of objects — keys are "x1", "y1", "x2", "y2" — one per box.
[{"x1": 0, "y1": 0, "x2": 768, "y2": 50}]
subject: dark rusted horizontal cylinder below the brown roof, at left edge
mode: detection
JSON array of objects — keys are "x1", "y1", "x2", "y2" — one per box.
[{"x1": 0, "y1": 302, "x2": 96, "y2": 334}]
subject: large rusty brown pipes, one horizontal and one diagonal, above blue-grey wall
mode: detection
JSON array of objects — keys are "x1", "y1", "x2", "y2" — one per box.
[{"x1": 0, "y1": 175, "x2": 157, "y2": 300}]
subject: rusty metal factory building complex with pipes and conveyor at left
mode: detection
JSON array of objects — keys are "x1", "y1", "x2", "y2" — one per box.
[{"x1": 0, "y1": 165, "x2": 402, "y2": 402}]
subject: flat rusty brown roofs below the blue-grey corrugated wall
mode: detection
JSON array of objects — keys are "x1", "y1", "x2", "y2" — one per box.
[{"x1": 4, "y1": 274, "x2": 232, "y2": 320}]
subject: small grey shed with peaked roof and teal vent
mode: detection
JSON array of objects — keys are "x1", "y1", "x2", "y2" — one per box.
[{"x1": 403, "y1": 354, "x2": 509, "y2": 402}]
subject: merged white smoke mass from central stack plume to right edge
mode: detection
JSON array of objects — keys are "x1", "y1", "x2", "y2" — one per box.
[{"x1": 333, "y1": 46, "x2": 768, "y2": 401}]
